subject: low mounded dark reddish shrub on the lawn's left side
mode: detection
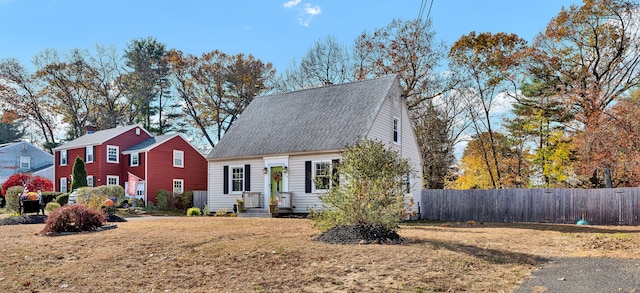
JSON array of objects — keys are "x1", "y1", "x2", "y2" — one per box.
[{"x1": 40, "y1": 204, "x2": 106, "y2": 234}]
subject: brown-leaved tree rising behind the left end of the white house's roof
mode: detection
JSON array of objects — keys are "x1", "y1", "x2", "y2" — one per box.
[{"x1": 166, "y1": 49, "x2": 275, "y2": 147}]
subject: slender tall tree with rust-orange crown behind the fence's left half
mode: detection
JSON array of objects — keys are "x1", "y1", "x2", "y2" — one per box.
[{"x1": 449, "y1": 32, "x2": 526, "y2": 188}]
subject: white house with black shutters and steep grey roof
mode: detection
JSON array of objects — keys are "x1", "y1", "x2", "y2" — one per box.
[{"x1": 207, "y1": 75, "x2": 422, "y2": 213}]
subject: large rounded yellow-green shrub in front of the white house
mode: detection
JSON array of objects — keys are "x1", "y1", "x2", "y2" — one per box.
[{"x1": 309, "y1": 140, "x2": 411, "y2": 230}]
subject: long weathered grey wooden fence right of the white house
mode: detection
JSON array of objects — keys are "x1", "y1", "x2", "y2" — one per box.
[{"x1": 420, "y1": 188, "x2": 640, "y2": 225}]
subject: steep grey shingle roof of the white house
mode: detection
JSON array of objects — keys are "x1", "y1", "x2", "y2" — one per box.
[{"x1": 207, "y1": 75, "x2": 396, "y2": 160}]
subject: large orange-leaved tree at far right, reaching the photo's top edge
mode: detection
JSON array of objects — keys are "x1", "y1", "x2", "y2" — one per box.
[{"x1": 534, "y1": 0, "x2": 640, "y2": 186}]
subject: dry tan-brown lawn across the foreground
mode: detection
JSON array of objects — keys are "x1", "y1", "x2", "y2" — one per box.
[{"x1": 0, "y1": 217, "x2": 640, "y2": 292}]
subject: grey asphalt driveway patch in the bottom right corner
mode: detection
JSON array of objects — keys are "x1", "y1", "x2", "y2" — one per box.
[{"x1": 513, "y1": 256, "x2": 640, "y2": 293}]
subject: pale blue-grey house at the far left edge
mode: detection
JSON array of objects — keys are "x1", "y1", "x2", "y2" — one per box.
[{"x1": 0, "y1": 141, "x2": 53, "y2": 184}]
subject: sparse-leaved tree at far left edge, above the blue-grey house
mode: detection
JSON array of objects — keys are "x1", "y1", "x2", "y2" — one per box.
[{"x1": 0, "y1": 59, "x2": 59, "y2": 153}]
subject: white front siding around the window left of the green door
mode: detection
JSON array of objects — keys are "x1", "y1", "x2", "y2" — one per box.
[{"x1": 207, "y1": 158, "x2": 264, "y2": 212}]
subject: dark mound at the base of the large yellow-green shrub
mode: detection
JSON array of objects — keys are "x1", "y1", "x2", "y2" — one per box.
[{"x1": 316, "y1": 224, "x2": 404, "y2": 244}]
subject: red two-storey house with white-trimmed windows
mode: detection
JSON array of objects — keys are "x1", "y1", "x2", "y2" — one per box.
[{"x1": 54, "y1": 125, "x2": 207, "y2": 203}]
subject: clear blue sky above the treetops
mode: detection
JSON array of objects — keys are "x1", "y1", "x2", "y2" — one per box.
[{"x1": 0, "y1": 0, "x2": 581, "y2": 72}]
